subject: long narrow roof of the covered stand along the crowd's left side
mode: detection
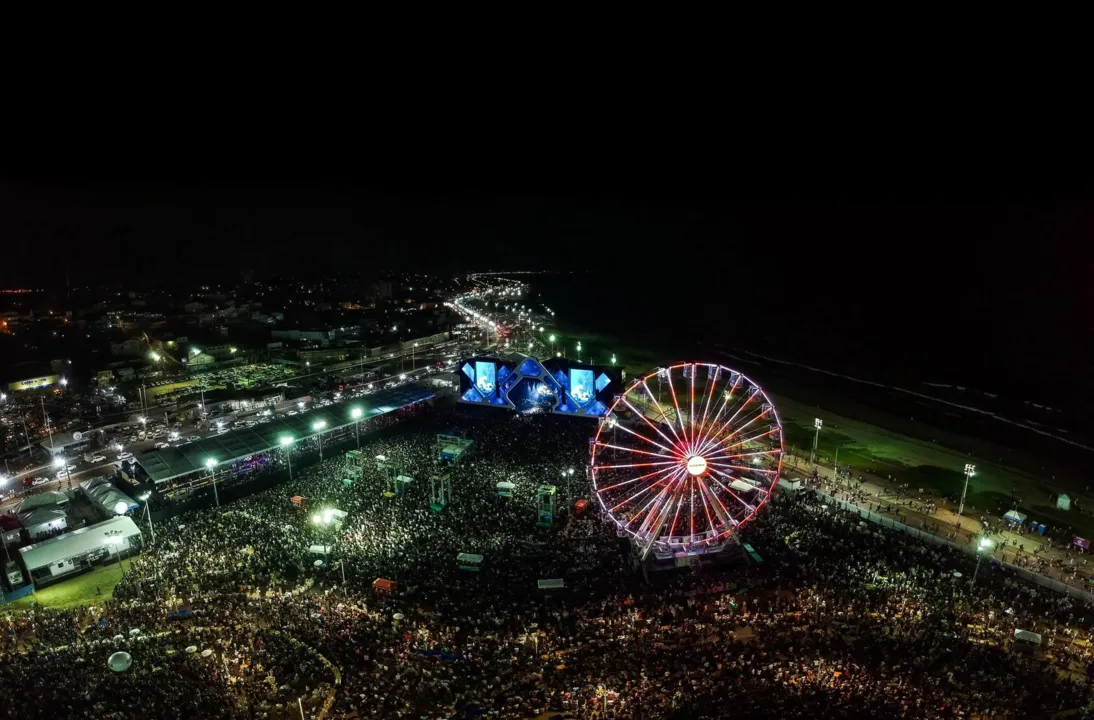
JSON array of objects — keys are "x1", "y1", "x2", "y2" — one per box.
[{"x1": 137, "y1": 385, "x2": 433, "y2": 483}]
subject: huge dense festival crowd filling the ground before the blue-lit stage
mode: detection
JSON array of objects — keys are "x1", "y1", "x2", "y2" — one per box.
[{"x1": 0, "y1": 408, "x2": 1094, "y2": 720}]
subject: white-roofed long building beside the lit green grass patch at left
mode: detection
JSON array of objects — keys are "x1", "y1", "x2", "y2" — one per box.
[{"x1": 19, "y1": 518, "x2": 141, "y2": 588}]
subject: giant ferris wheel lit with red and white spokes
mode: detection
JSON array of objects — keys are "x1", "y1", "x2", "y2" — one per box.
[{"x1": 589, "y1": 362, "x2": 782, "y2": 557}]
